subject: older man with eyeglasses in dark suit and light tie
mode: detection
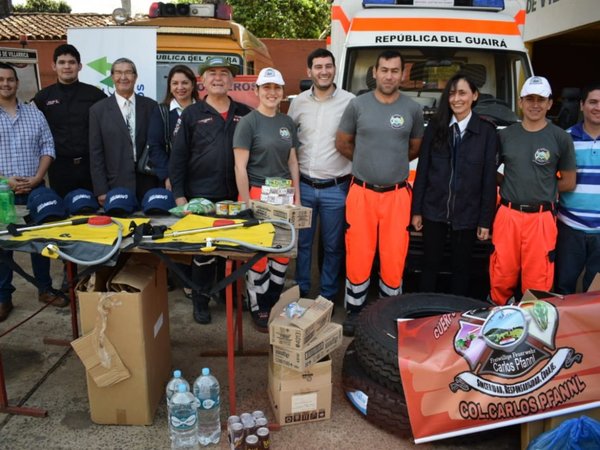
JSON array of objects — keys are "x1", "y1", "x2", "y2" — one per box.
[{"x1": 90, "y1": 58, "x2": 158, "y2": 205}]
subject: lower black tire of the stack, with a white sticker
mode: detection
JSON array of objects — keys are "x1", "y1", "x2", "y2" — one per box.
[{"x1": 342, "y1": 342, "x2": 412, "y2": 438}]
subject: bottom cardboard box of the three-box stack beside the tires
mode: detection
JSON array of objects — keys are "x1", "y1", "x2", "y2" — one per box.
[{"x1": 268, "y1": 357, "x2": 331, "y2": 426}]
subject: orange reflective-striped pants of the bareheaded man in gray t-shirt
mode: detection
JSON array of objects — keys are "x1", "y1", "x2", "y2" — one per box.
[{"x1": 345, "y1": 184, "x2": 411, "y2": 310}]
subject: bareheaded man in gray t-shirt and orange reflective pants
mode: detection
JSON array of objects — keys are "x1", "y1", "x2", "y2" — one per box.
[{"x1": 336, "y1": 50, "x2": 424, "y2": 336}]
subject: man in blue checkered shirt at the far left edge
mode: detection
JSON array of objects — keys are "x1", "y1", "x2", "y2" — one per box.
[{"x1": 0, "y1": 63, "x2": 63, "y2": 322}]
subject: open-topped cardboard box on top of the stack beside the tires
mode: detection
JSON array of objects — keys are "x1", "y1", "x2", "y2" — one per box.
[{"x1": 269, "y1": 286, "x2": 333, "y2": 350}]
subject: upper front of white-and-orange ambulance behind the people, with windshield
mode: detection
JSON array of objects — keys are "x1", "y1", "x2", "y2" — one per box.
[{"x1": 330, "y1": 0, "x2": 532, "y2": 125}]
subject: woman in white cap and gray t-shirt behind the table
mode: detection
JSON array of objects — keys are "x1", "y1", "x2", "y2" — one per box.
[{"x1": 233, "y1": 67, "x2": 300, "y2": 332}]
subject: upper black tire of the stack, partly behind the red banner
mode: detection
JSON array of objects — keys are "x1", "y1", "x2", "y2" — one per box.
[{"x1": 354, "y1": 293, "x2": 490, "y2": 393}]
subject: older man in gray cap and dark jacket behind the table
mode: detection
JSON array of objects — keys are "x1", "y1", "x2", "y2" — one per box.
[{"x1": 169, "y1": 57, "x2": 250, "y2": 324}]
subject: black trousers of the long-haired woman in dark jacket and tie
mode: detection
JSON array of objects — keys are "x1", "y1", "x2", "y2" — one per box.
[{"x1": 419, "y1": 218, "x2": 477, "y2": 296}]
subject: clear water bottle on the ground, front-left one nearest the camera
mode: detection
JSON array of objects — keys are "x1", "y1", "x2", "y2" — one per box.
[{"x1": 169, "y1": 383, "x2": 199, "y2": 450}]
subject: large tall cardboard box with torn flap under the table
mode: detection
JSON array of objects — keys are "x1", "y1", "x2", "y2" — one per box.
[{"x1": 77, "y1": 254, "x2": 171, "y2": 425}]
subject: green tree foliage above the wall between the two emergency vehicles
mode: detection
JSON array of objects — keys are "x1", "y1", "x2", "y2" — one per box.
[{"x1": 173, "y1": 0, "x2": 331, "y2": 39}]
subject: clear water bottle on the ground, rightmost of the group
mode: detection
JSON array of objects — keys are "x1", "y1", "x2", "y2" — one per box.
[{"x1": 194, "y1": 367, "x2": 221, "y2": 446}]
